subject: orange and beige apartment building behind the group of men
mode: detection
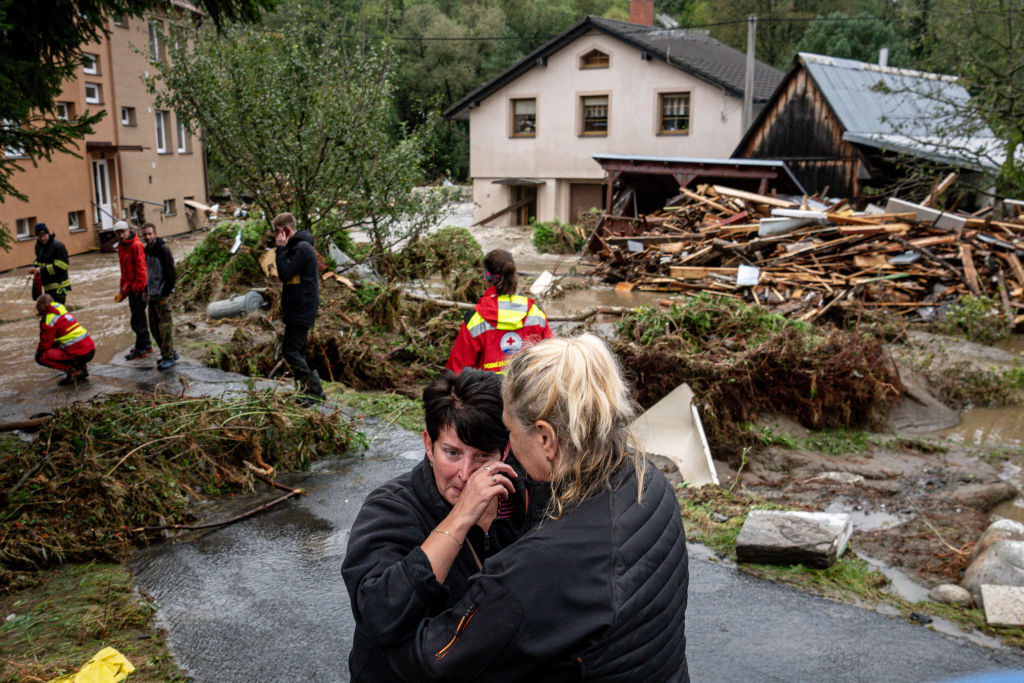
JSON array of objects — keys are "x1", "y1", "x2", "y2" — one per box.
[{"x1": 0, "y1": 0, "x2": 207, "y2": 274}]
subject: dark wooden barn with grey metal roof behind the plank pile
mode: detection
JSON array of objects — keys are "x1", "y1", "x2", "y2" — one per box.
[{"x1": 732, "y1": 52, "x2": 981, "y2": 204}]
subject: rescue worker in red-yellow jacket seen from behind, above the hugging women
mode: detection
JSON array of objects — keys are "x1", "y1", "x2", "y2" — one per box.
[{"x1": 445, "y1": 249, "x2": 552, "y2": 373}]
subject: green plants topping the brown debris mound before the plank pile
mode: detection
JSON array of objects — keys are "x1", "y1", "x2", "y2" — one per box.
[{"x1": 618, "y1": 292, "x2": 813, "y2": 350}]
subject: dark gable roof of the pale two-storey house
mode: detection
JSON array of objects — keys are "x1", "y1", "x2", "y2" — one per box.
[{"x1": 443, "y1": 16, "x2": 784, "y2": 119}]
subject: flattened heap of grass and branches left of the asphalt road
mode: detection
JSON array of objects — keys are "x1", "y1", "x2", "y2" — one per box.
[{"x1": 0, "y1": 391, "x2": 365, "y2": 568}]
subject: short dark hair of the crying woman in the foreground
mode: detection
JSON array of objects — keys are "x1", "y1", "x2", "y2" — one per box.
[{"x1": 423, "y1": 368, "x2": 509, "y2": 453}]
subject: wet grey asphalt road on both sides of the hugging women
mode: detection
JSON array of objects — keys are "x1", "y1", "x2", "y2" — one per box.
[{"x1": 133, "y1": 411, "x2": 1024, "y2": 681}]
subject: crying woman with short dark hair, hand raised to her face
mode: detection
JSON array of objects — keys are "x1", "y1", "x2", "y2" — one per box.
[{"x1": 342, "y1": 370, "x2": 528, "y2": 681}]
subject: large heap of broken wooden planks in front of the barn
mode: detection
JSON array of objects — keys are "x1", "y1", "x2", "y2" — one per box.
[{"x1": 590, "y1": 185, "x2": 1024, "y2": 325}]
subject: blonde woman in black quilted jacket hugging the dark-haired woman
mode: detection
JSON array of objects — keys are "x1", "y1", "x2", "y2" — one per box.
[{"x1": 389, "y1": 335, "x2": 689, "y2": 681}]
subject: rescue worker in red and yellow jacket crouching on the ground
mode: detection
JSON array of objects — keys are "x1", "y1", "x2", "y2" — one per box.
[{"x1": 36, "y1": 294, "x2": 96, "y2": 386}]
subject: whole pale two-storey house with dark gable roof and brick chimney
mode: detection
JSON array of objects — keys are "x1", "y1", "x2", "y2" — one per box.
[{"x1": 444, "y1": 0, "x2": 783, "y2": 225}]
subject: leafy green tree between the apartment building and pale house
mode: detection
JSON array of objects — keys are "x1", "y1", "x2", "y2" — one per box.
[{"x1": 151, "y1": 5, "x2": 457, "y2": 253}]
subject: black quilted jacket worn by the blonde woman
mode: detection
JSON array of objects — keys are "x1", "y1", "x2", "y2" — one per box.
[{"x1": 392, "y1": 458, "x2": 689, "y2": 683}]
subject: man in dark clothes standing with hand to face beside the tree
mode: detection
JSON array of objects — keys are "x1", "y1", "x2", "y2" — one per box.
[{"x1": 272, "y1": 213, "x2": 327, "y2": 400}]
